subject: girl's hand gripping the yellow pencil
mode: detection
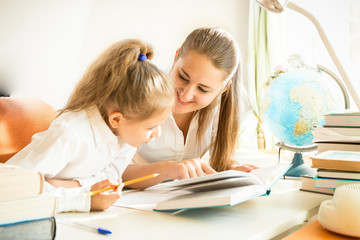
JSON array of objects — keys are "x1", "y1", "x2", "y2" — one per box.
[{"x1": 91, "y1": 179, "x2": 124, "y2": 211}]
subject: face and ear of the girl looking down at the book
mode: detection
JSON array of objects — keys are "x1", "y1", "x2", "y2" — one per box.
[{"x1": 109, "y1": 108, "x2": 171, "y2": 147}]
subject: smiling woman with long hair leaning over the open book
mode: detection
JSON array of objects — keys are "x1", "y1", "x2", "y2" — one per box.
[{"x1": 123, "y1": 27, "x2": 256, "y2": 188}]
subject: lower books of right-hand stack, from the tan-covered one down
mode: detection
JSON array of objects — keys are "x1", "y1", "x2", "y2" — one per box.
[{"x1": 301, "y1": 151, "x2": 360, "y2": 194}]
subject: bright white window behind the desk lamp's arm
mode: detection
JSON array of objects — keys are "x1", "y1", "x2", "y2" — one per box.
[{"x1": 285, "y1": 0, "x2": 360, "y2": 109}]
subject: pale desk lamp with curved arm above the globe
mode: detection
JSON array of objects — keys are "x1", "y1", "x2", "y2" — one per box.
[{"x1": 256, "y1": 0, "x2": 360, "y2": 110}]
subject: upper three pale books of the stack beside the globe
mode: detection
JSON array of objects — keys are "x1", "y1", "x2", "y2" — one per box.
[{"x1": 312, "y1": 112, "x2": 360, "y2": 153}]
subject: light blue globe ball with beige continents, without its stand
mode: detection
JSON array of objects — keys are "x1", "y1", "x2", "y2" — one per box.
[{"x1": 262, "y1": 69, "x2": 341, "y2": 146}]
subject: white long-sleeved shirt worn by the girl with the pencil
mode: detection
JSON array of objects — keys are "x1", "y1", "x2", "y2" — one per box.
[{"x1": 7, "y1": 107, "x2": 136, "y2": 212}]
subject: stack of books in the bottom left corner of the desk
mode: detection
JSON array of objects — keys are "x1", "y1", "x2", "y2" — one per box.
[{"x1": 0, "y1": 163, "x2": 56, "y2": 240}]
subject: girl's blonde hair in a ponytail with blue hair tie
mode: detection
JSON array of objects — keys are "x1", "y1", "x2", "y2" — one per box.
[{"x1": 61, "y1": 39, "x2": 174, "y2": 120}]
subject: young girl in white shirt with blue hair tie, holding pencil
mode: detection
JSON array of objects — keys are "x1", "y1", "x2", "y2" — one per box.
[{"x1": 7, "y1": 40, "x2": 174, "y2": 212}]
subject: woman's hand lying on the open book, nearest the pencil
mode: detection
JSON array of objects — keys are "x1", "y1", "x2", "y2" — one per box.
[{"x1": 161, "y1": 159, "x2": 216, "y2": 179}]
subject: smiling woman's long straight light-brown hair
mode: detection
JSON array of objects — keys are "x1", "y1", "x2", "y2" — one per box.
[{"x1": 175, "y1": 27, "x2": 241, "y2": 171}]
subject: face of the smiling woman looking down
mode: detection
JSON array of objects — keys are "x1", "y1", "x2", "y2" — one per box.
[{"x1": 171, "y1": 51, "x2": 225, "y2": 114}]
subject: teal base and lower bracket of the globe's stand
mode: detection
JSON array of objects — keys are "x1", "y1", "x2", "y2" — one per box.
[{"x1": 276, "y1": 142, "x2": 316, "y2": 177}]
